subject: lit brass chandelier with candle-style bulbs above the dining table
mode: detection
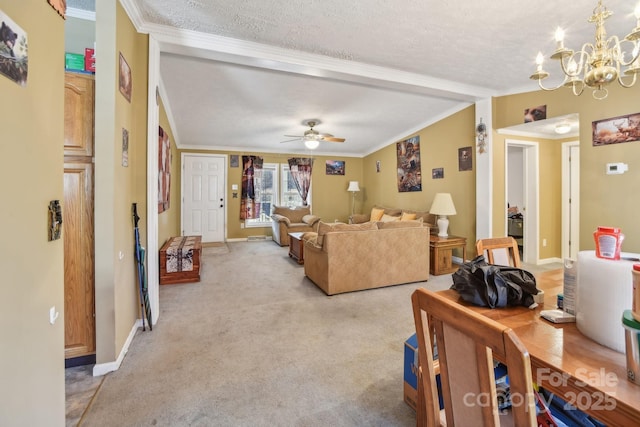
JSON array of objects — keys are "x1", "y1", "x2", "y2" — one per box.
[{"x1": 530, "y1": 0, "x2": 640, "y2": 99}]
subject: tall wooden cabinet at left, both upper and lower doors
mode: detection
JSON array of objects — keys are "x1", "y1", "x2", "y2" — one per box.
[{"x1": 62, "y1": 73, "x2": 96, "y2": 359}]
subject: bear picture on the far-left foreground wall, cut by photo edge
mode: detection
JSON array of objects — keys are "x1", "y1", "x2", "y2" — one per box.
[{"x1": 0, "y1": 10, "x2": 29, "y2": 86}]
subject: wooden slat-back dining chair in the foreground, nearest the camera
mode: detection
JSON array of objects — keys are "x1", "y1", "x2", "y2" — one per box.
[{"x1": 411, "y1": 289, "x2": 537, "y2": 427}]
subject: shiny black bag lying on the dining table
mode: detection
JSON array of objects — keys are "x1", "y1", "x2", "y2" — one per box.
[{"x1": 451, "y1": 255, "x2": 538, "y2": 308}]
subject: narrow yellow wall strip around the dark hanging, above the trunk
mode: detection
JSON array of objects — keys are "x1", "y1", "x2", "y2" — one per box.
[{"x1": 158, "y1": 97, "x2": 182, "y2": 247}]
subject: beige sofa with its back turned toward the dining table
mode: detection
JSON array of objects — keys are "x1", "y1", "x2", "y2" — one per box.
[{"x1": 303, "y1": 221, "x2": 429, "y2": 295}]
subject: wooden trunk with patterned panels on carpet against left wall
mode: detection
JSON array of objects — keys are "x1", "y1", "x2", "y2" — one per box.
[{"x1": 160, "y1": 236, "x2": 202, "y2": 285}]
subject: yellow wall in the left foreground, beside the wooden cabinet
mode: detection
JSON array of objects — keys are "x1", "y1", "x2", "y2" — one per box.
[{"x1": 0, "y1": 0, "x2": 65, "y2": 426}]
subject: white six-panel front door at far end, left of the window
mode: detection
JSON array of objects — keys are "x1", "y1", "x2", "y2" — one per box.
[{"x1": 182, "y1": 153, "x2": 226, "y2": 242}]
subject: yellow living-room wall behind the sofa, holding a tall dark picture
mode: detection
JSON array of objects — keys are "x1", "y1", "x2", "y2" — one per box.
[{"x1": 361, "y1": 106, "x2": 476, "y2": 257}]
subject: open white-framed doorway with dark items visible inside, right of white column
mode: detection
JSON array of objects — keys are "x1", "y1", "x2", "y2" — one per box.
[{"x1": 504, "y1": 139, "x2": 539, "y2": 264}]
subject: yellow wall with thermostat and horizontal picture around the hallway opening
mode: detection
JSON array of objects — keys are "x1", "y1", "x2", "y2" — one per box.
[{"x1": 493, "y1": 84, "x2": 640, "y2": 254}]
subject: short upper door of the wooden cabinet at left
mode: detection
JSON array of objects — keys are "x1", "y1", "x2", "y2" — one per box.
[{"x1": 64, "y1": 73, "x2": 95, "y2": 156}]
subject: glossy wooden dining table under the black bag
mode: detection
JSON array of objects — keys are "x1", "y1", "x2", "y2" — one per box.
[{"x1": 439, "y1": 269, "x2": 640, "y2": 426}]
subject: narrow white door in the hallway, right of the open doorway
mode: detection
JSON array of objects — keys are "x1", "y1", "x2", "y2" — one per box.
[{"x1": 562, "y1": 141, "x2": 580, "y2": 260}]
